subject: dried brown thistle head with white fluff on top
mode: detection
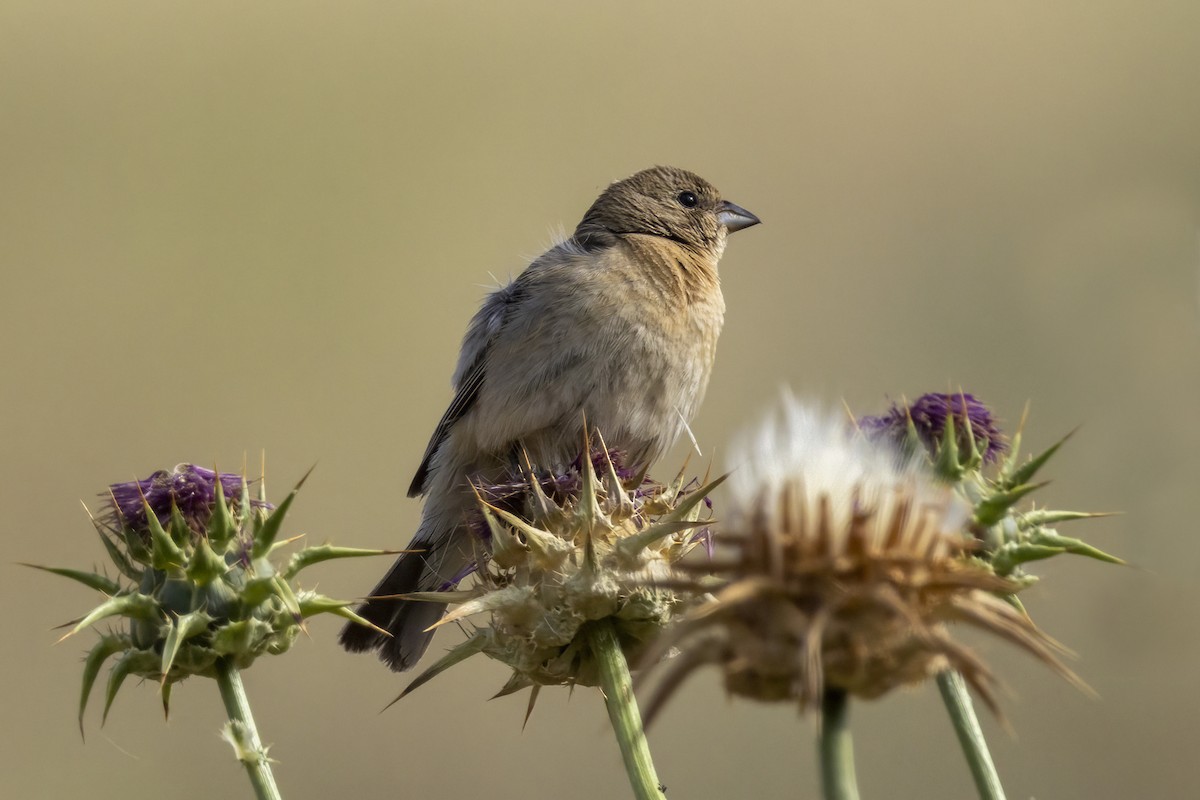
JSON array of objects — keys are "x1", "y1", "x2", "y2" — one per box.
[{"x1": 646, "y1": 402, "x2": 1075, "y2": 720}]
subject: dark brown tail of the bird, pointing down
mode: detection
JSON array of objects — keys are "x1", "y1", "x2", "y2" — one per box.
[{"x1": 337, "y1": 553, "x2": 446, "y2": 672}]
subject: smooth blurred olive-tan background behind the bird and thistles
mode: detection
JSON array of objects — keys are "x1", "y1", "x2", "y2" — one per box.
[{"x1": 0, "y1": 0, "x2": 1200, "y2": 800}]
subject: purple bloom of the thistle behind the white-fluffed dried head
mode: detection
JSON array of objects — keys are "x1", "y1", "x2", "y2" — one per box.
[{"x1": 858, "y1": 392, "x2": 1008, "y2": 464}]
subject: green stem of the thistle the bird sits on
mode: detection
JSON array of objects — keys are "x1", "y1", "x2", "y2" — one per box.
[{"x1": 587, "y1": 620, "x2": 665, "y2": 800}]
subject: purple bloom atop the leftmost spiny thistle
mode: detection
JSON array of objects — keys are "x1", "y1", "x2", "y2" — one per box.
[{"x1": 108, "y1": 464, "x2": 270, "y2": 536}]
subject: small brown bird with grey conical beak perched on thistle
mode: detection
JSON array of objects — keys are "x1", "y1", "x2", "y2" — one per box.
[{"x1": 341, "y1": 167, "x2": 758, "y2": 670}]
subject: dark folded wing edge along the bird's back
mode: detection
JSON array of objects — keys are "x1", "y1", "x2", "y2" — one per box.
[{"x1": 408, "y1": 278, "x2": 523, "y2": 498}]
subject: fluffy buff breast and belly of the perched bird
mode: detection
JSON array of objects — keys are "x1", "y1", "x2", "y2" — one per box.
[{"x1": 456, "y1": 241, "x2": 725, "y2": 469}]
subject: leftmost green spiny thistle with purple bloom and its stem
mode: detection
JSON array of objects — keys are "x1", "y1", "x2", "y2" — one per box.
[{"x1": 30, "y1": 464, "x2": 386, "y2": 798}]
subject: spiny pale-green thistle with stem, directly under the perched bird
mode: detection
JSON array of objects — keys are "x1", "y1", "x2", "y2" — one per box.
[{"x1": 396, "y1": 441, "x2": 724, "y2": 799}]
